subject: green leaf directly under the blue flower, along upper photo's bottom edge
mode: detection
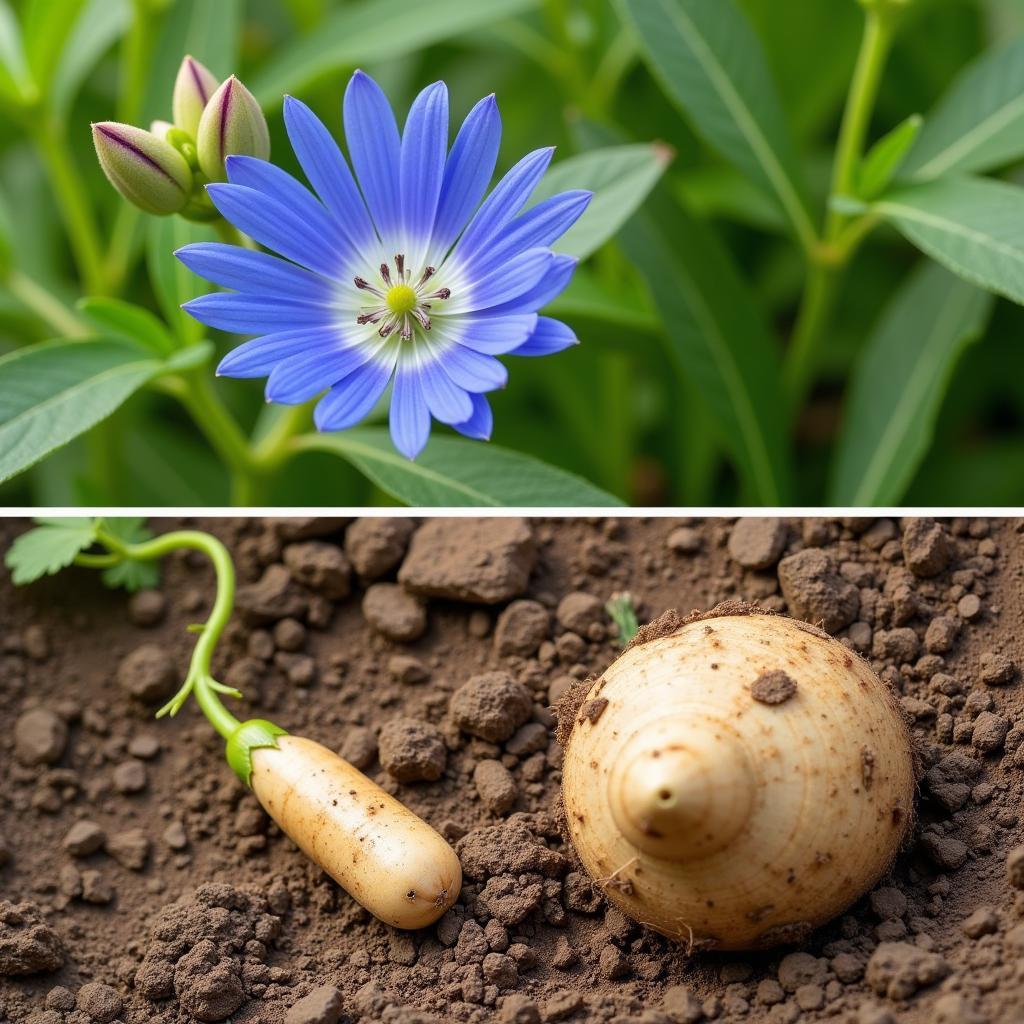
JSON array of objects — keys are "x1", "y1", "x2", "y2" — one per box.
[{"x1": 302, "y1": 427, "x2": 623, "y2": 508}]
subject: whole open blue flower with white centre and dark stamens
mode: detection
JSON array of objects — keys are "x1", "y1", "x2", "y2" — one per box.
[{"x1": 177, "y1": 72, "x2": 591, "y2": 459}]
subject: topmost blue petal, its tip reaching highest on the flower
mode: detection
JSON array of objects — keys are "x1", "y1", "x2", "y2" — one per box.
[{"x1": 344, "y1": 71, "x2": 401, "y2": 241}]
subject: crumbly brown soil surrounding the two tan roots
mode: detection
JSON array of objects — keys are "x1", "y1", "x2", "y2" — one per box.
[{"x1": 0, "y1": 518, "x2": 1024, "y2": 1024}]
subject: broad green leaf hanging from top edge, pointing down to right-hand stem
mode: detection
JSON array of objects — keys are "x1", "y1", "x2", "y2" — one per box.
[{"x1": 617, "y1": 0, "x2": 815, "y2": 248}]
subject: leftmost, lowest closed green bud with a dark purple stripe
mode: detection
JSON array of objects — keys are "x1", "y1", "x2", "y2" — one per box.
[{"x1": 92, "y1": 121, "x2": 193, "y2": 214}]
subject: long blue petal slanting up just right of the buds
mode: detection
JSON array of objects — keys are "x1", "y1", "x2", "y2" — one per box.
[{"x1": 285, "y1": 96, "x2": 377, "y2": 251}]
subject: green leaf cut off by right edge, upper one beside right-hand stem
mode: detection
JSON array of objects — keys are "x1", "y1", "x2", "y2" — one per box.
[{"x1": 902, "y1": 39, "x2": 1024, "y2": 181}]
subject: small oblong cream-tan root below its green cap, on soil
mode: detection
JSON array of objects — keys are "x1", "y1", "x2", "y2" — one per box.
[{"x1": 251, "y1": 735, "x2": 462, "y2": 929}]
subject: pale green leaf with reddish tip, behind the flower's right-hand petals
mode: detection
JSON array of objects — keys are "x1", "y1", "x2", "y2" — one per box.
[{"x1": 530, "y1": 142, "x2": 673, "y2": 259}]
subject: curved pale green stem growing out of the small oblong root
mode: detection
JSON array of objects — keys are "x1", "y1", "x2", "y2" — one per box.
[{"x1": 96, "y1": 527, "x2": 241, "y2": 739}]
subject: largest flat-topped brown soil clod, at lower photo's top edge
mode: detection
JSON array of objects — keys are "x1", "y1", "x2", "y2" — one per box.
[{"x1": 398, "y1": 517, "x2": 537, "y2": 604}]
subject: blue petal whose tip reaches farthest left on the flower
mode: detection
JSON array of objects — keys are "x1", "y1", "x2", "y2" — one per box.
[{"x1": 174, "y1": 242, "x2": 337, "y2": 302}]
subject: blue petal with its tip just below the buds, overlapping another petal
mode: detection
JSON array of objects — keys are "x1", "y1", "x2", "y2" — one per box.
[{"x1": 206, "y1": 184, "x2": 345, "y2": 279}]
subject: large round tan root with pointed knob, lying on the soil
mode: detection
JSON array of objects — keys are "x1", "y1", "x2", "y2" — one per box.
[{"x1": 558, "y1": 602, "x2": 918, "y2": 949}]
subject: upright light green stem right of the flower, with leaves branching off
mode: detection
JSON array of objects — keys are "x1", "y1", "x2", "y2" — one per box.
[{"x1": 783, "y1": 8, "x2": 896, "y2": 415}]
